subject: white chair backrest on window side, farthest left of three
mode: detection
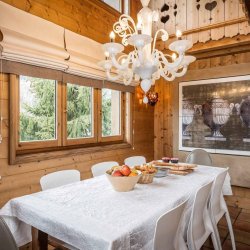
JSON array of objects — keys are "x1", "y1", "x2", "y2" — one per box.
[{"x1": 40, "y1": 169, "x2": 81, "y2": 190}]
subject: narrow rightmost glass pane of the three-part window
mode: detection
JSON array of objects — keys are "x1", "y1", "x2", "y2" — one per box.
[{"x1": 102, "y1": 89, "x2": 121, "y2": 136}]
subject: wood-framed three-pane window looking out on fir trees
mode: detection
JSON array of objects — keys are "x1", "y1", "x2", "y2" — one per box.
[{"x1": 10, "y1": 75, "x2": 131, "y2": 162}]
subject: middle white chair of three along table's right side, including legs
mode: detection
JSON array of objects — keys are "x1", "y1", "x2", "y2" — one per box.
[{"x1": 187, "y1": 182, "x2": 221, "y2": 250}]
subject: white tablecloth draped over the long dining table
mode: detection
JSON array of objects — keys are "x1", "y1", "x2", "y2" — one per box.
[{"x1": 0, "y1": 166, "x2": 232, "y2": 250}]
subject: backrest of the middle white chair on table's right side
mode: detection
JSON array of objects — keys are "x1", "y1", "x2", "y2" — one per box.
[{"x1": 187, "y1": 181, "x2": 213, "y2": 249}]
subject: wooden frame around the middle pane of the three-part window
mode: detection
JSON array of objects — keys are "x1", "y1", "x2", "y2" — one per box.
[{"x1": 62, "y1": 83, "x2": 98, "y2": 146}]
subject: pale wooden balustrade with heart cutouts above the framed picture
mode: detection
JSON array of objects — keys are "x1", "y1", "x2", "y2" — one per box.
[{"x1": 150, "y1": 0, "x2": 250, "y2": 43}]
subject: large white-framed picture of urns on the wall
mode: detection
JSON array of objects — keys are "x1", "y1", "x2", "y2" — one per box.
[{"x1": 179, "y1": 75, "x2": 250, "y2": 155}]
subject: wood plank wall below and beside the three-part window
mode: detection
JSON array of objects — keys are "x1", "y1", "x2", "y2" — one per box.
[{"x1": 0, "y1": 75, "x2": 154, "y2": 207}]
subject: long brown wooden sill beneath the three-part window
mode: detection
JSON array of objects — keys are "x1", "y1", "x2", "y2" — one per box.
[{"x1": 10, "y1": 142, "x2": 132, "y2": 165}]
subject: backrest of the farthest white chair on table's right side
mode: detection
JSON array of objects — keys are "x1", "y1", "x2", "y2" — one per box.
[{"x1": 210, "y1": 168, "x2": 228, "y2": 223}]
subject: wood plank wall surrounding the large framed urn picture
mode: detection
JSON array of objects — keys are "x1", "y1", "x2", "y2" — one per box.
[{"x1": 154, "y1": 41, "x2": 250, "y2": 210}]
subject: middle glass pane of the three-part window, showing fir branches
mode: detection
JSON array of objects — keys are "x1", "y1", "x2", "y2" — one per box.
[{"x1": 67, "y1": 83, "x2": 93, "y2": 139}]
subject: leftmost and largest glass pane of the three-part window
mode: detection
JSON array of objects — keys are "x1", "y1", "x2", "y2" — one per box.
[{"x1": 19, "y1": 76, "x2": 56, "y2": 142}]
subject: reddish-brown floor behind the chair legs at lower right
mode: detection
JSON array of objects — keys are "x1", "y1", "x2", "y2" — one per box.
[{"x1": 202, "y1": 206, "x2": 250, "y2": 250}]
